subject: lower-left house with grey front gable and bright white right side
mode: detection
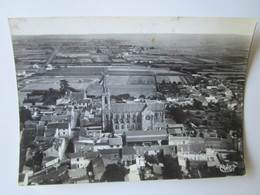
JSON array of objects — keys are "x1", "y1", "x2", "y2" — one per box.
[{"x1": 43, "y1": 138, "x2": 68, "y2": 160}]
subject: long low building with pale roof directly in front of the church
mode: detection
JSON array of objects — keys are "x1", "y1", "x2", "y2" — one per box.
[{"x1": 125, "y1": 130, "x2": 168, "y2": 146}]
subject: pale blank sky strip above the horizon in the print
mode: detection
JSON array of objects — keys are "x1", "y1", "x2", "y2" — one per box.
[{"x1": 9, "y1": 17, "x2": 256, "y2": 36}]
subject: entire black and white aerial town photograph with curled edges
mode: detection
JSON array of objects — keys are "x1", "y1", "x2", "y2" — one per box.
[{"x1": 9, "y1": 17, "x2": 256, "y2": 186}]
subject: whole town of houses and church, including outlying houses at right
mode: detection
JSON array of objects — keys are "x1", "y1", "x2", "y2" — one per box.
[{"x1": 19, "y1": 70, "x2": 244, "y2": 185}]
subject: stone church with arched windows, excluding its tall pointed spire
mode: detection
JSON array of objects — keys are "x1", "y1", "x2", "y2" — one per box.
[{"x1": 102, "y1": 93, "x2": 165, "y2": 134}]
